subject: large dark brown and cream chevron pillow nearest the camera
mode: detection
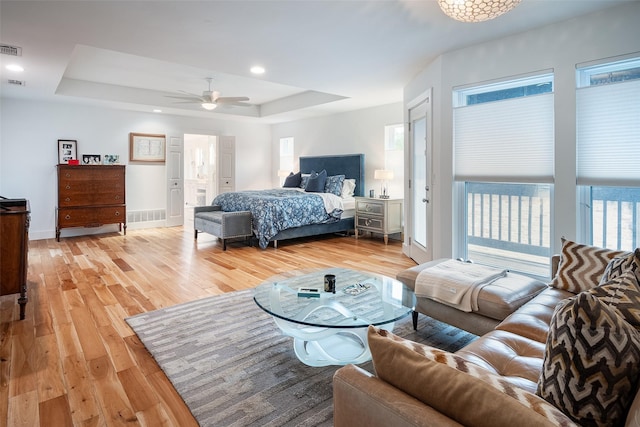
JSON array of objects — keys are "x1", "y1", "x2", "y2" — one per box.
[{"x1": 537, "y1": 292, "x2": 640, "y2": 426}]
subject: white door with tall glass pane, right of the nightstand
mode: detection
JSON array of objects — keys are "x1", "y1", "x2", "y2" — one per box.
[{"x1": 407, "y1": 91, "x2": 433, "y2": 264}]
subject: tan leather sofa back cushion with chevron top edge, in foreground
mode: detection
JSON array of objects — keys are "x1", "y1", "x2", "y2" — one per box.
[{"x1": 368, "y1": 326, "x2": 574, "y2": 427}]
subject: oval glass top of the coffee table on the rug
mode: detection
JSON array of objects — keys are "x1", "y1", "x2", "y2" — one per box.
[{"x1": 254, "y1": 268, "x2": 415, "y2": 329}]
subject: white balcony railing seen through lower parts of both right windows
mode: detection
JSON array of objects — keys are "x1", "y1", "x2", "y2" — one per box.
[{"x1": 466, "y1": 182, "x2": 640, "y2": 277}]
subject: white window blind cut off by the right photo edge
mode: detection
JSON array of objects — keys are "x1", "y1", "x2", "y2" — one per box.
[{"x1": 576, "y1": 80, "x2": 640, "y2": 186}]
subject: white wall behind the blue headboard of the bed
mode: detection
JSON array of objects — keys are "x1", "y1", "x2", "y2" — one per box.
[{"x1": 271, "y1": 103, "x2": 403, "y2": 194}]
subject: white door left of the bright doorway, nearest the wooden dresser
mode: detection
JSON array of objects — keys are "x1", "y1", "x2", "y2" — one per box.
[{"x1": 166, "y1": 136, "x2": 184, "y2": 227}]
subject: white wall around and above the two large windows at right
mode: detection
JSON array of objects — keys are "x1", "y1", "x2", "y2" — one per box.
[{"x1": 404, "y1": 2, "x2": 640, "y2": 258}]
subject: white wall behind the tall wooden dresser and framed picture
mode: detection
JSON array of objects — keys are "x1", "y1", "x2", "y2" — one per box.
[{"x1": 0, "y1": 99, "x2": 271, "y2": 239}]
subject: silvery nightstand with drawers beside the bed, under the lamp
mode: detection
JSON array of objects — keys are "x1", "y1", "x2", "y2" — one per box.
[{"x1": 355, "y1": 197, "x2": 403, "y2": 245}]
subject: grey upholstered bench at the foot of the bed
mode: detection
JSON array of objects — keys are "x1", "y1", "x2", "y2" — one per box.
[{"x1": 193, "y1": 206, "x2": 252, "y2": 251}]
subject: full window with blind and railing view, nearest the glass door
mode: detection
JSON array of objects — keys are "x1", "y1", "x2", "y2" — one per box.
[{"x1": 453, "y1": 74, "x2": 554, "y2": 277}]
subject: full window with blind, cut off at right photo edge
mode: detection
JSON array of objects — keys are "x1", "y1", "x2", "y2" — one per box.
[{"x1": 576, "y1": 58, "x2": 640, "y2": 250}]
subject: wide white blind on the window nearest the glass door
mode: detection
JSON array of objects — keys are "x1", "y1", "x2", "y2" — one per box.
[{"x1": 453, "y1": 93, "x2": 554, "y2": 183}]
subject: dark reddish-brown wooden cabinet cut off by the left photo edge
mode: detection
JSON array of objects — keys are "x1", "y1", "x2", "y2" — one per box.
[{"x1": 0, "y1": 196, "x2": 30, "y2": 320}]
